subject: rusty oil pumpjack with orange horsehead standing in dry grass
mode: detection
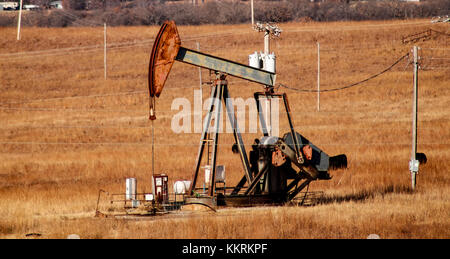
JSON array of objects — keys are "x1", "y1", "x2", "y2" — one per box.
[{"x1": 148, "y1": 21, "x2": 347, "y2": 208}]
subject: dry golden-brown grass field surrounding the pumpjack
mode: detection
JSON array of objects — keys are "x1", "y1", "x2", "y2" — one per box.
[{"x1": 0, "y1": 20, "x2": 450, "y2": 239}]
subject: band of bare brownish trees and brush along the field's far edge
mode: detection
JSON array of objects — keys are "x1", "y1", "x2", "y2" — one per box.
[{"x1": 0, "y1": 0, "x2": 450, "y2": 27}]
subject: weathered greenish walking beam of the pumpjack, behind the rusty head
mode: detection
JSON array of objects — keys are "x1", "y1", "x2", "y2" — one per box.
[{"x1": 175, "y1": 47, "x2": 276, "y2": 86}]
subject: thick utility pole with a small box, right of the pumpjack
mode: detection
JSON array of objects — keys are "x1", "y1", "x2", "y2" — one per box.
[{"x1": 409, "y1": 46, "x2": 419, "y2": 190}]
